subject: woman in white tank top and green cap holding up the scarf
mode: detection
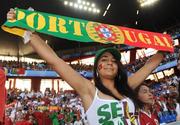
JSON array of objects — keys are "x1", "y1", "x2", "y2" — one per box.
[{"x1": 7, "y1": 9, "x2": 163, "y2": 125}]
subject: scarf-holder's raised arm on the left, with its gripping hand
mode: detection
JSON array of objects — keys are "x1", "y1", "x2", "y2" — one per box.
[{"x1": 7, "y1": 9, "x2": 95, "y2": 98}]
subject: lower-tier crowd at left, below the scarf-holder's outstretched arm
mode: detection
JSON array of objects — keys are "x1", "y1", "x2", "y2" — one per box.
[{"x1": 6, "y1": 88, "x2": 87, "y2": 125}]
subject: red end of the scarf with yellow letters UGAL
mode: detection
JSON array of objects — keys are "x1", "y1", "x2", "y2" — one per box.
[{"x1": 120, "y1": 27, "x2": 174, "y2": 52}]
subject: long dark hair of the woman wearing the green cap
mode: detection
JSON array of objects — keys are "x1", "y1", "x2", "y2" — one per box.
[{"x1": 93, "y1": 56, "x2": 136, "y2": 105}]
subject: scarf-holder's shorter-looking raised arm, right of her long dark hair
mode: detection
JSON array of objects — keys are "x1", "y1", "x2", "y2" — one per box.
[{"x1": 128, "y1": 52, "x2": 164, "y2": 89}]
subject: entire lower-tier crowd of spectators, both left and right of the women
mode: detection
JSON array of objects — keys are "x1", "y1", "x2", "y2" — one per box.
[{"x1": 3, "y1": 75, "x2": 180, "y2": 125}]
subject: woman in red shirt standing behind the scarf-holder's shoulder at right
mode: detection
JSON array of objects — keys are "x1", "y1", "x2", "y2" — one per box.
[{"x1": 135, "y1": 84, "x2": 159, "y2": 125}]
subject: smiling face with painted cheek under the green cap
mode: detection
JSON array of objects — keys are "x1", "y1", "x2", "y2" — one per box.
[{"x1": 97, "y1": 52, "x2": 118, "y2": 79}]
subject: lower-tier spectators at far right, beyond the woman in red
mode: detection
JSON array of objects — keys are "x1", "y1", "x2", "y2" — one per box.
[{"x1": 149, "y1": 74, "x2": 180, "y2": 123}]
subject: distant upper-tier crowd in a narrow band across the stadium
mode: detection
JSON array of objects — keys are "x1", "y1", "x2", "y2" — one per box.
[{"x1": 0, "y1": 48, "x2": 179, "y2": 74}]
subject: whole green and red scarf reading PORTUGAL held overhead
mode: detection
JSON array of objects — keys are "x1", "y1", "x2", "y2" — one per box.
[{"x1": 2, "y1": 8, "x2": 174, "y2": 52}]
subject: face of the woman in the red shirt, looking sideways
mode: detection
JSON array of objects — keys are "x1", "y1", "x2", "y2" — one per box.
[{"x1": 138, "y1": 85, "x2": 154, "y2": 105}]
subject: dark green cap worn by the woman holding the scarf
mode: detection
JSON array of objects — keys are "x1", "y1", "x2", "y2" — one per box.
[{"x1": 94, "y1": 47, "x2": 121, "y2": 63}]
